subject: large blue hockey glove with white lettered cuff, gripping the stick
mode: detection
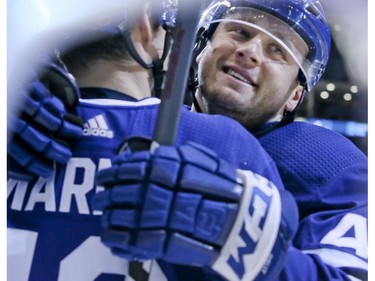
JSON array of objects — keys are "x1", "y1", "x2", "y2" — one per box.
[{"x1": 92, "y1": 143, "x2": 298, "y2": 280}]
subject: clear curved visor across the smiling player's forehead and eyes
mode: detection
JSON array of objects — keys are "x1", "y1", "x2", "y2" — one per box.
[{"x1": 200, "y1": 5, "x2": 310, "y2": 81}]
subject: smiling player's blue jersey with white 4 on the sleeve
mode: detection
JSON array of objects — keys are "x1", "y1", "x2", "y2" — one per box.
[{"x1": 259, "y1": 122, "x2": 368, "y2": 281}]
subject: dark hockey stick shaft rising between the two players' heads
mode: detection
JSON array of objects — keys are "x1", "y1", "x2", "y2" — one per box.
[{"x1": 153, "y1": 0, "x2": 201, "y2": 145}]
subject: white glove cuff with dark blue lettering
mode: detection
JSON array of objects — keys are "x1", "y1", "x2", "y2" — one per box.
[{"x1": 212, "y1": 170, "x2": 286, "y2": 281}]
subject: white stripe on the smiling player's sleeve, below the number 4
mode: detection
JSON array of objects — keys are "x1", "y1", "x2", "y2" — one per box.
[{"x1": 302, "y1": 249, "x2": 368, "y2": 270}]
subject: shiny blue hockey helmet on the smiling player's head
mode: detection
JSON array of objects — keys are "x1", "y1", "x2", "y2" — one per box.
[{"x1": 196, "y1": 0, "x2": 331, "y2": 91}]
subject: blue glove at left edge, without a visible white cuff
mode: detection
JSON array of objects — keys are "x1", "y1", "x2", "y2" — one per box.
[{"x1": 7, "y1": 59, "x2": 83, "y2": 181}]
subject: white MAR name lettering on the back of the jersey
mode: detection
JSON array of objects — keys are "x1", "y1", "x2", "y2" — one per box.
[{"x1": 7, "y1": 158, "x2": 111, "y2": 215}]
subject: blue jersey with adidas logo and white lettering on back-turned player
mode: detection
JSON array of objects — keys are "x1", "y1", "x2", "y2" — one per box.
[{"x1": 7, "y1": 89, "x2": 282, "y2": 281}]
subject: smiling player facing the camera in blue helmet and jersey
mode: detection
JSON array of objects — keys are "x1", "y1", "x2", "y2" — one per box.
[{"x1": 187, "y1": 0, "x2": 368, "y2": 280}]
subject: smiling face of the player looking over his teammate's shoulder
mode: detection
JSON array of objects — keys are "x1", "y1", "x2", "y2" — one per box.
[{"x1": 197, "y1": 9, "x2": 307, "y2": 129}]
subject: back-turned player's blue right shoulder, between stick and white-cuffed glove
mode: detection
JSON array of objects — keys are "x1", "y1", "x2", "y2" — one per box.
[{"x1": 177, "y1": 111, "x2": 283, "y2": 188}]
